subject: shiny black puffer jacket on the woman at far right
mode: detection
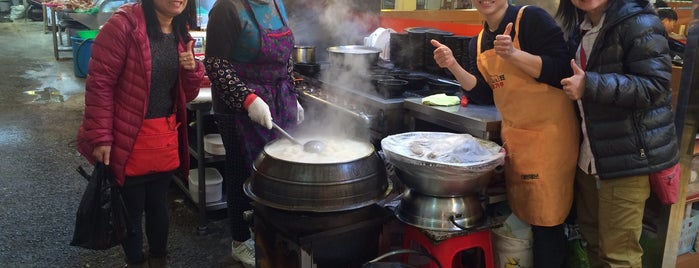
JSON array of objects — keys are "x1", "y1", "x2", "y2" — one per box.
[{"x1": 569, "y1": 0, "x2": 679, "y2": 179}]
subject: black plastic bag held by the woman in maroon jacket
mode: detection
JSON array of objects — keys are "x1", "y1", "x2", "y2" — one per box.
[{"x1": 70, "y1": 163, "x2": 133, "y2": 250}]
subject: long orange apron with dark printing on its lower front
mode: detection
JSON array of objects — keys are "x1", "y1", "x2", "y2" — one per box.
[{"x1": 477, "y1": 7, "x2": 580, "y2": 226}]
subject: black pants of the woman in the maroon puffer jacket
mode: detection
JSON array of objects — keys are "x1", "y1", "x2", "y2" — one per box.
[{"x1": 121, "y1": 172, "x2": 173, "y2": 264}]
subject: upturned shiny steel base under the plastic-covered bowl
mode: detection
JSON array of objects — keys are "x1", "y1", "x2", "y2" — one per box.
[{"x1": 395, "y1": 190, "x2": 484, "y2": 231}]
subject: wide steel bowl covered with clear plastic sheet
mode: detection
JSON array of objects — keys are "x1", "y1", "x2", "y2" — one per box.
[{"x1": 381, "y1": 132, "x2": 505, "y2": 196}]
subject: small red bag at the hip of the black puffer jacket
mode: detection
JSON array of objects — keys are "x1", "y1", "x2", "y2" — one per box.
[{"x1": 648, "y1": 163, "x2": 682, "y2": 205}]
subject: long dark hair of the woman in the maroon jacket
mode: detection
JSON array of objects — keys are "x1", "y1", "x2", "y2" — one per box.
[{"x1": 141, "y1": 0, "x2": 197, "y2": 41}]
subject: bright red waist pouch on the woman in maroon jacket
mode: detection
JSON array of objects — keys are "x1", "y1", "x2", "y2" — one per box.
[{"x1": 125, "y1": 115, "x2": 180, "y2": 176}]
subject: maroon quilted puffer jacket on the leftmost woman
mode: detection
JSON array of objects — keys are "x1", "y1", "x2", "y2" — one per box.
[{"x1": 77, "y1": 4, "x2": 204, "y2": 185}]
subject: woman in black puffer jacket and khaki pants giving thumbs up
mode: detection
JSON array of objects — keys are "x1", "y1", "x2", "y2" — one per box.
[{"x1": 557, "y1": 0, "x2": 679, "y2": 267}]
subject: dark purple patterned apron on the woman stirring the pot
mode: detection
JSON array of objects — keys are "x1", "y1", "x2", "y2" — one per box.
[{"x1": 215, "y1": 1, "x2": 297, "y2": 241}]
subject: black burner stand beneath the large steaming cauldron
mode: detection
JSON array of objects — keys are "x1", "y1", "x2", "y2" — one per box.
[{"x1": 253, "y1": 202, "x2": 392, "y2": 268}]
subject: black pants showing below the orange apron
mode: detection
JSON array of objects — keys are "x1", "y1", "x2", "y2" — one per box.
[{"x1": 532, "y1": 223, "x2": 568, "y2": 268}]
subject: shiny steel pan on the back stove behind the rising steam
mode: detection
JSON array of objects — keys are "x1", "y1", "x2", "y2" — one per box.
[{"x1": 327, "y1": 45, "x2": 382, "y2": 68}]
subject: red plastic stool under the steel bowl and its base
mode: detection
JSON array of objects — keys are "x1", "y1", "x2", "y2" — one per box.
[{"x1": 403, "y1": 225, "x2": 495, "y2": 268}]
